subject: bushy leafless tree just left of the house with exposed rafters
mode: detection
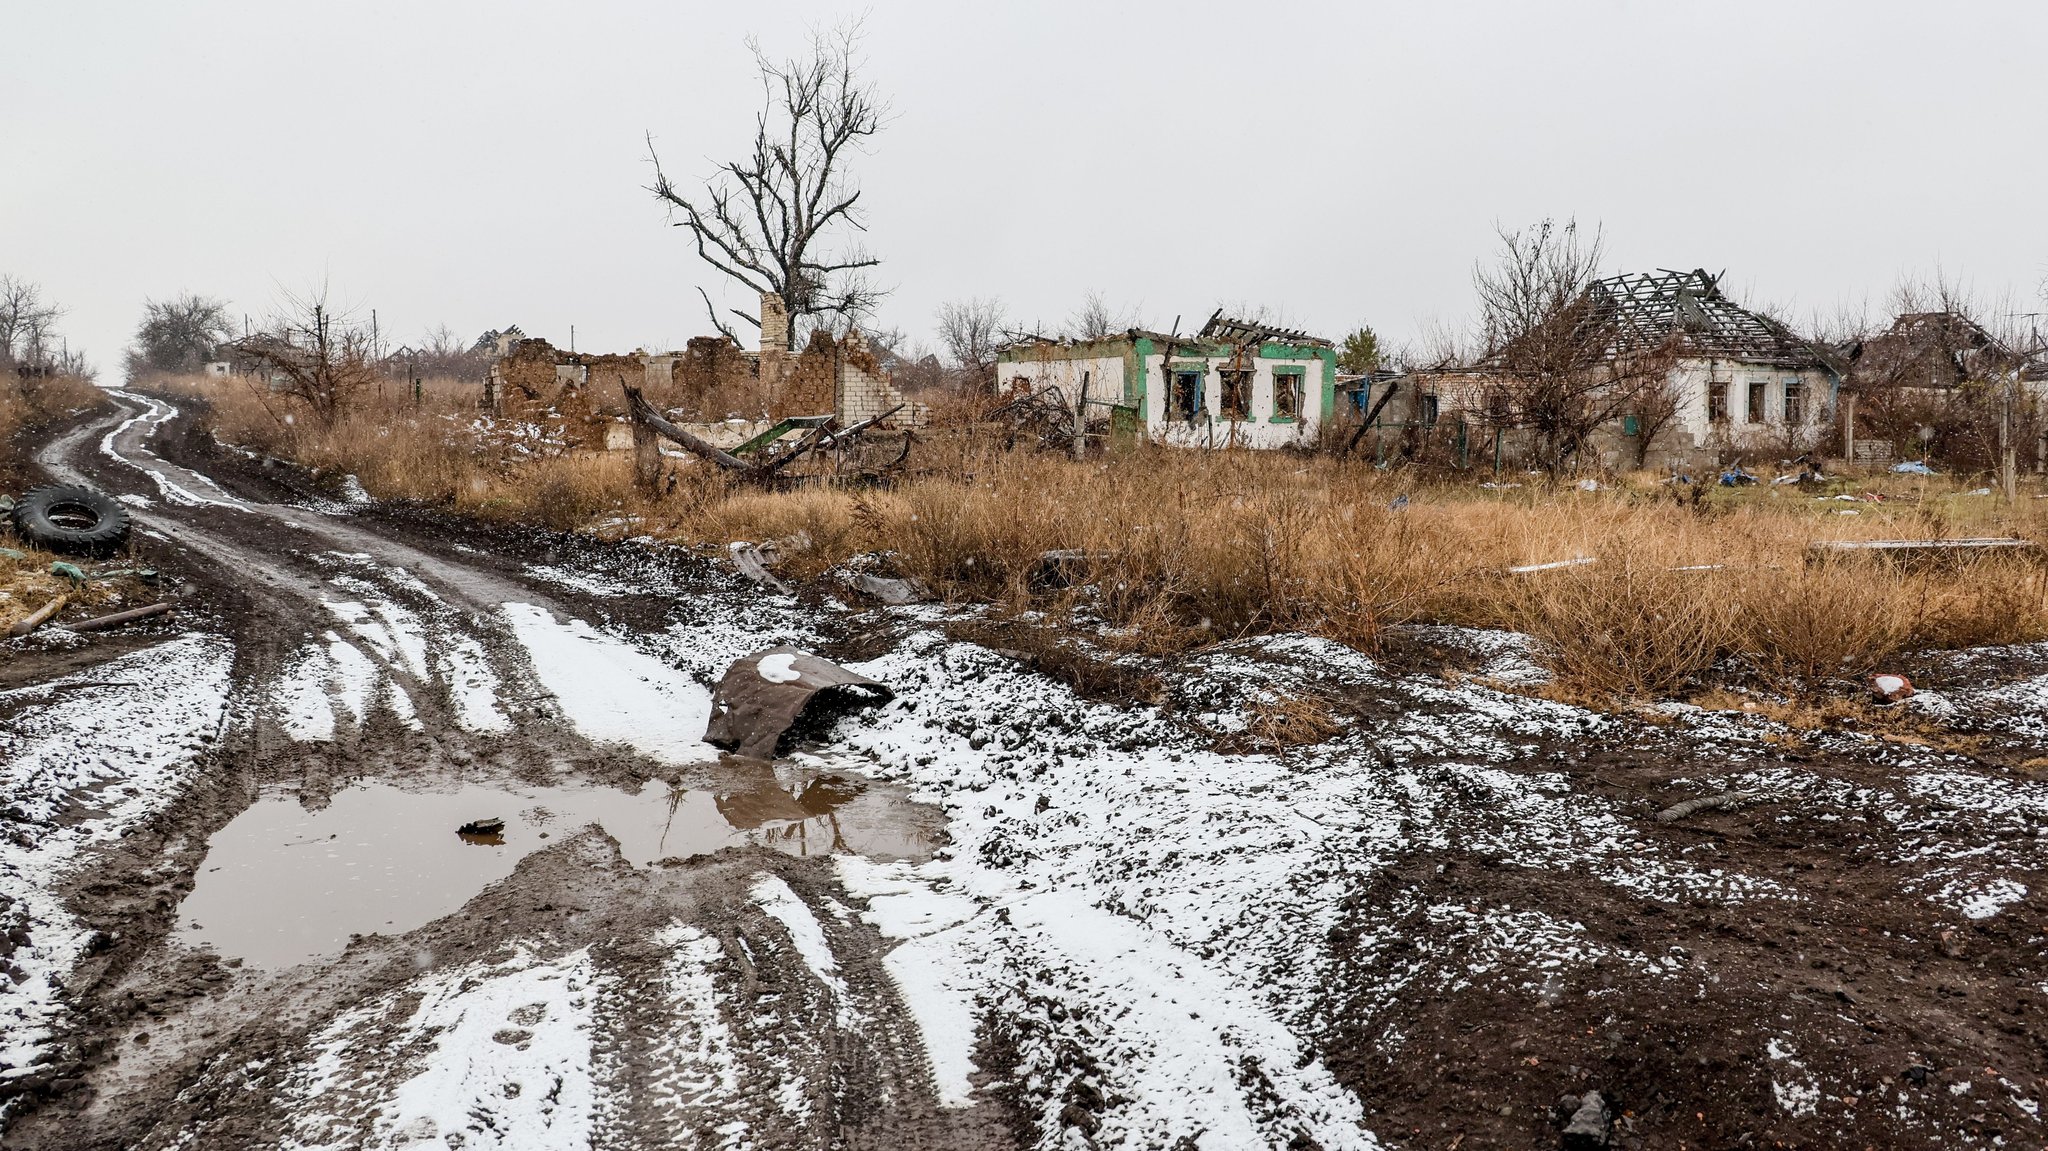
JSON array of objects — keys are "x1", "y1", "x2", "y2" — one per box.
[{"x1": 1473, "y1": 219, "x2": 1675, "y2": 473}]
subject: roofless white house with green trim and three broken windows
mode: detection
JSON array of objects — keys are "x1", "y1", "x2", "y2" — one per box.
[{"x1": 995, "y1": 311, "x2": 1337, "y2": 449}]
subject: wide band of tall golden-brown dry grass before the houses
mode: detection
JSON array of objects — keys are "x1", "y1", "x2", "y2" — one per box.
[{"x1": 163, "y1": 376, "x2": 2048, "y2": 698}]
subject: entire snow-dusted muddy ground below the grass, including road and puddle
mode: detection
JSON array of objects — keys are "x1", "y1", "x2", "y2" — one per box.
[{"x1": 0, "y1": 393, "x2": 2048, "y2": 1149}]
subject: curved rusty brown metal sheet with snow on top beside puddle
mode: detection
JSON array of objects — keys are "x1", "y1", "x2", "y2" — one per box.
[{"x1": 705, "y1": 647, "x2": 895, "y2": 760}]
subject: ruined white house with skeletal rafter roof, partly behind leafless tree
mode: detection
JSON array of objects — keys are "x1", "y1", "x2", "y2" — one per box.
[{"x1": 1354, "y1": 268, "x2": 1841, "y2": 469}]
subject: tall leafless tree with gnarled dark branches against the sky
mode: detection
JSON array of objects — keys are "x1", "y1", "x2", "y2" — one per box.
[{"x1": 647, "y1": 23, "x2": 887, "y2": 346}]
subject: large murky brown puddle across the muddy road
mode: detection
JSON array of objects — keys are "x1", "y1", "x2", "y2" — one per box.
[{"x1": 178, "y1": 766, "x2": 940, "y2": 967}]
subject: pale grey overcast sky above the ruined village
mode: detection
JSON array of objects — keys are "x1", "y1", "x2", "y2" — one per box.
[{"x1": 0, "y1": 0, "x2": 2048, "y2": 375}]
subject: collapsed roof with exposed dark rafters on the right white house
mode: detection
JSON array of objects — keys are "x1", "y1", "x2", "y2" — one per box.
[{"x1": 1585, "y1": 268, "x2": 1825, "y2": 367}]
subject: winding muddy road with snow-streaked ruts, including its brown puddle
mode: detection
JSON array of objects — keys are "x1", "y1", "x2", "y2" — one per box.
[{"x1": 6, "y1": 395, "x2": 993, "y2": 1147}]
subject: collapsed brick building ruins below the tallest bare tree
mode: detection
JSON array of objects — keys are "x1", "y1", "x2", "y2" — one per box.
[{"x1": 483, "y1": 295, "x2": 922, "y2": 446}]
